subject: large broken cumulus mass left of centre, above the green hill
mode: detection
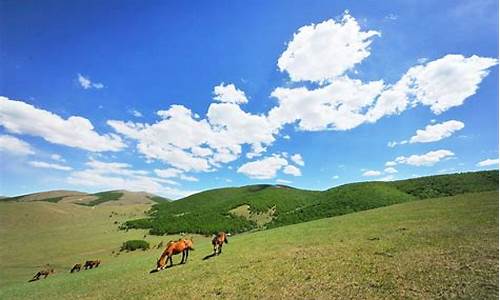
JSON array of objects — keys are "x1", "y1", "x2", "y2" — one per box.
[{"x1": 108, "y1": 86, "x2": 278, "y2": 173}]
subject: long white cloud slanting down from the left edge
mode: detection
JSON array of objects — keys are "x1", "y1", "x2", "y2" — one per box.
[{"x1": 0, "y1": 96, "x2": 125, "y2": 152}]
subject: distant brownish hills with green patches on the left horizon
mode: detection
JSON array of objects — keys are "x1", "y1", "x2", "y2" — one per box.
[{"x1": 2, "y1": 190, "x2": 170, "y2": 206}]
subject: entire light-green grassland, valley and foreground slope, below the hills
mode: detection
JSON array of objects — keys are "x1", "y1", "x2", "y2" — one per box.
[{"x1": 0, "y1": 191, "x2": 498, "y2": 299}]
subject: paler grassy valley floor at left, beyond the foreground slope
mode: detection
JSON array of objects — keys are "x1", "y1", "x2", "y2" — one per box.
[{"x1": 0, "y1": 201, "x2": 165, "y2": 288}]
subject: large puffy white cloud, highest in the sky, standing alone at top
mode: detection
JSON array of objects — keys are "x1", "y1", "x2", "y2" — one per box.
[{"x1": 278, "y1": 13, "x2": 380, "y2": 82}]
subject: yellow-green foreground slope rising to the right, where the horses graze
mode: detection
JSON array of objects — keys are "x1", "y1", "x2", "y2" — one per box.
[{"x1": 0, "y1": 192, "x2": 498, "y2": 299}]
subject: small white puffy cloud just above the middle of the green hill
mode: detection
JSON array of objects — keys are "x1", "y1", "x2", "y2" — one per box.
[{"x1": 237, "y1": 154, "x2": 288, "y2": 179}]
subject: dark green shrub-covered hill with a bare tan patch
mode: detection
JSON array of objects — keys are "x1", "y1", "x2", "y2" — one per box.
[{"x1": 123, "y1": 170, "x2": 498, "y2": 235}]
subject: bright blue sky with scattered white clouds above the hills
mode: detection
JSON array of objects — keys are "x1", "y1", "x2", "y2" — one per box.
[{"x1": 0, "y1": 0, "x2": 499, "y2": 199}]
